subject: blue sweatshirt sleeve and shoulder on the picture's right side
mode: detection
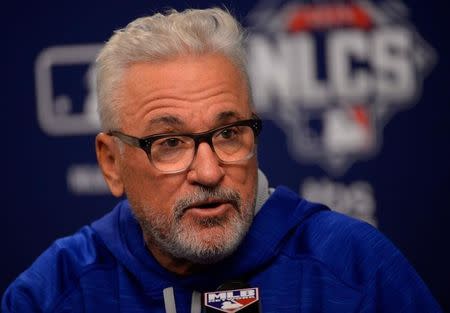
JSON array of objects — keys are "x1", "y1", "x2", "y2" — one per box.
[{"x1": 300, "y1": 211, "x2": 442, "y2": 313}]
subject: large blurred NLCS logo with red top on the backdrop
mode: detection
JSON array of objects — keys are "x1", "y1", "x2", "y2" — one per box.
[{"x1": 248, "y1": 0, "x2": 435, "y2": 175}]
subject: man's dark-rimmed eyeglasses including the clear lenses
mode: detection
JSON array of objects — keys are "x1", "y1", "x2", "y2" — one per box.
[{"x1": 108, "y1": 115, "x2": 262, "y2": 173}]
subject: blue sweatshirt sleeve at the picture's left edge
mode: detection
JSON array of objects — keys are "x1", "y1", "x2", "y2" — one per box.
[{"x1": 1, "y1": 227, "x2": 97, "y2": 313}]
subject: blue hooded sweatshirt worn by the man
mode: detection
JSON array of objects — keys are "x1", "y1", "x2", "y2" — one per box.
[{"x1": 2, "y1": 187, "x2": 441, "y2": 313}]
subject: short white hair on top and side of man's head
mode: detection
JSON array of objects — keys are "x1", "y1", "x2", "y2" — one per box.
[{"x1": 96, "y1": 8, "x2": 250, "y2": 130}]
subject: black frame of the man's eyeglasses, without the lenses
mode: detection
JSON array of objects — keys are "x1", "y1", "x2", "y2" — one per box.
[{"x1": 107, "y1": 114, "x2": 262, "y2": 173}]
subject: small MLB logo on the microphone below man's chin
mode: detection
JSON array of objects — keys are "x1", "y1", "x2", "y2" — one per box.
[{"x1": 204, "y1": 288, "x2": 259, "y2": 313}]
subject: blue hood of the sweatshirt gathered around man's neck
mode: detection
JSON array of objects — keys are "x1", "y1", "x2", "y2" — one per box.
[{"x1": 92, "y1": 187, "x2": 327, "y2": 296}]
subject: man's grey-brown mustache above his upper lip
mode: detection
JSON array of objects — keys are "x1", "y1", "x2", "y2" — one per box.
[{"x1": 174, "y1": 186, "x2": 242, "y2": 220}]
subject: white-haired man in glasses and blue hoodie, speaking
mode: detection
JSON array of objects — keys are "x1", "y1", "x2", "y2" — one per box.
[{"x1": 2, "y1": 9, "x2": 440, "y2": 313}]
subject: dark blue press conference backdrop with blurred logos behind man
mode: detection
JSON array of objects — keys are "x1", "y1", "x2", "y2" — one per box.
[{"x1": 0, "y1": 0, "x2": 450, "y2": 309}]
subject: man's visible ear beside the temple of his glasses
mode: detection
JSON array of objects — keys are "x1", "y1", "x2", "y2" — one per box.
[{"x1": 95, "y1": 133, "x2": 124, "y2": 197}]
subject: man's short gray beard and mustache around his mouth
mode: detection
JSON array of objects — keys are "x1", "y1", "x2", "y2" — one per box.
[{"x1": 133, "y1": 187, "x2": 255, "y2": 264}]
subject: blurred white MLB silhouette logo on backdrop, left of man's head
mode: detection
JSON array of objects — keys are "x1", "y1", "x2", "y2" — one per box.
[{"x1": 35, "y1": 44, "x2": 103, "y2": 136}]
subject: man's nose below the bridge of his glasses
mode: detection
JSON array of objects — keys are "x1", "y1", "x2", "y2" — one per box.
[{"x1": 187, "y1": 142, "x2": 225, "y2": 187}]
